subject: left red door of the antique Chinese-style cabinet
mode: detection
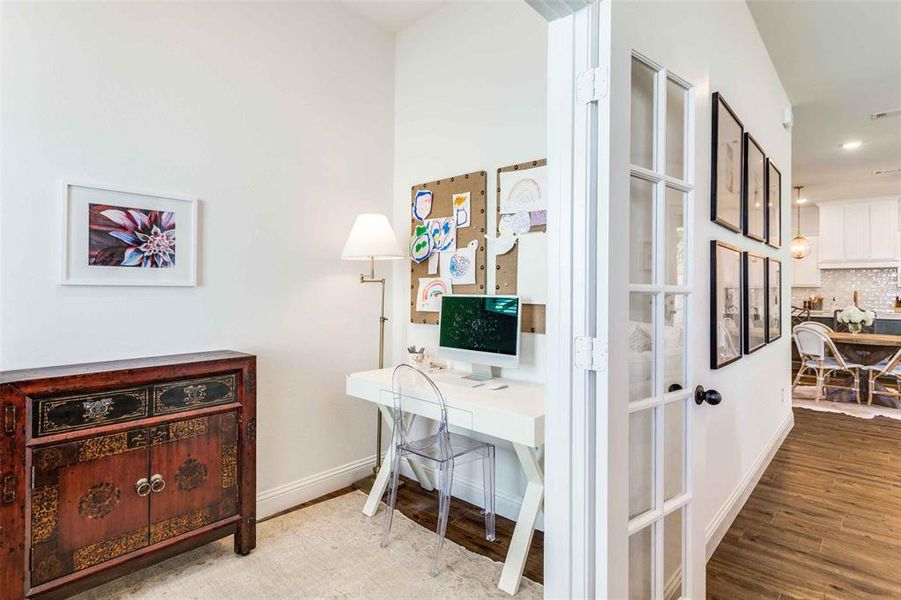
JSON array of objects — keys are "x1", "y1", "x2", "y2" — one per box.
[{"x1": 31, "y1": 429, "x2": 149, "y2": 586}]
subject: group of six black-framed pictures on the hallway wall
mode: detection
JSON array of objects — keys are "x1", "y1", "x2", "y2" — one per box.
[{"x1": 710, "y1": 92, "x2": 782, "y2": 369}]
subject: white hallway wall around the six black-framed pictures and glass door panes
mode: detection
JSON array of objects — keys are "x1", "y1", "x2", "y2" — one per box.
[{"x1": 610, "y1": 2, "x2": 792, "y2": 576}]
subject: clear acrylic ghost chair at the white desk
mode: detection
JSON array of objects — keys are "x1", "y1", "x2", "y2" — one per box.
[{"x1": 382, "y1": 365, "x2": 494, "y2": 576}]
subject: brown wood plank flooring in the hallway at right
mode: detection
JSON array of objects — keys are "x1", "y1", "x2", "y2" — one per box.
[{"x1": 707, "y1": 409, "x2": 901, "y2": 600}]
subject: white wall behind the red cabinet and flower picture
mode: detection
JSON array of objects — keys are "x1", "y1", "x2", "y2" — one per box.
[{"x1": 0, "y1": 2, "x2": 396, "y2": 516}]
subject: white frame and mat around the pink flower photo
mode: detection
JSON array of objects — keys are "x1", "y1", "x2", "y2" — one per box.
[{"x1": 60, "y1": 180, "x2": 198, "y2": 287}]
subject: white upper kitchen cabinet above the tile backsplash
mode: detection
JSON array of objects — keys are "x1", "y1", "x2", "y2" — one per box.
[{"x1": 819, "y1": 198, "x2": 901, "y2": 269}]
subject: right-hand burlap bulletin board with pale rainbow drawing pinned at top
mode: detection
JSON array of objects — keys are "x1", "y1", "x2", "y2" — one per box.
[{"x1": 494, "y1": 159, "x2": 547, "y2": 333}]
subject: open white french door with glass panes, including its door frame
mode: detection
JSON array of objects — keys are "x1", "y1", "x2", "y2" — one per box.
[{"x1": 540, "y1": 0, "x2": 706, "y2": 600}]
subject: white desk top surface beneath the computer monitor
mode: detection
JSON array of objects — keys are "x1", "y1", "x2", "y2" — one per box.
[{"x1": 347, "y1": 368, "x2": 544, "y2": 419}]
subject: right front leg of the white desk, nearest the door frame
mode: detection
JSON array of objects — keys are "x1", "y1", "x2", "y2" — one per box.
[{"x1": 498, "y1": 444, "x2": 544, "y2": 595}]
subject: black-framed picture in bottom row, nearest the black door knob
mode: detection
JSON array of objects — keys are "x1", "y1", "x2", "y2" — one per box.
[{"x1": 710, "y1": 240, "x2": 744, "y2": 369}]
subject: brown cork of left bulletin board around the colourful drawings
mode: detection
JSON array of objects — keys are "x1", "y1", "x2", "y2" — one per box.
[{"x1": 410, "y1": 171, "x2": 488, "y2": 325}]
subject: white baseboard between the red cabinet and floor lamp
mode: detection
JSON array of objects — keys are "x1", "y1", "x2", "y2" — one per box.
[{"x1": 257, "y1": 456, "x2": 375, "y2": 519}]
